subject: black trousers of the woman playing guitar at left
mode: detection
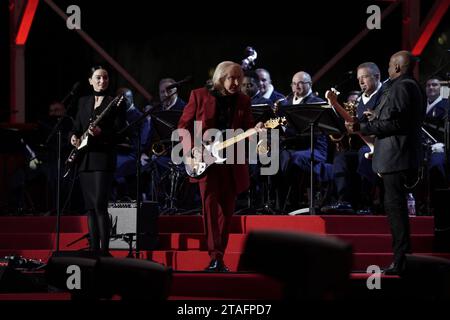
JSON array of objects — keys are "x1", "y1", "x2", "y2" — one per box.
[{"x1": 80, "y1": 171, "x2": 113, "y2": 252}]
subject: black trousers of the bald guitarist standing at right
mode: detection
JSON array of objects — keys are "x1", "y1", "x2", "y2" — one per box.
[{"x1": 382, "y1": 170, "x2": 417, "y2": 264}]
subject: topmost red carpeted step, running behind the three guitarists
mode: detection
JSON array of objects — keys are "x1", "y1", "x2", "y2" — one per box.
[{"x1": 0, "y1": 215, "x2": 434, "y2": 234}]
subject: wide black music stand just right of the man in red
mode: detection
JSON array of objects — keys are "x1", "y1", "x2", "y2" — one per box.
[{"x1": 280, "y1": 102, "x2": 345, "y2": 215}]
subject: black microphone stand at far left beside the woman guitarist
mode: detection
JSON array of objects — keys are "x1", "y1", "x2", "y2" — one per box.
[{"x1": 45, "y1": 89, "x2": 75, "y2": 253}]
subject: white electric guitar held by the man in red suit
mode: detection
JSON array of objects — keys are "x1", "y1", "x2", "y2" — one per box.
[{"x1": 184, "y1": 117, "x2": 286, "y2": 179}]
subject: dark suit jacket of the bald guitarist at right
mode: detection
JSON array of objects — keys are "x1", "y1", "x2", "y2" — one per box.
[{"x1": 361, "y1": 75, "x2": 426, "y2": 173}]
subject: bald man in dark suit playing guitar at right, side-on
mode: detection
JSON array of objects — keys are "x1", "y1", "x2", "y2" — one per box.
[{"x1": 346, "y1": 51, "x2": 426, "y2": 275}]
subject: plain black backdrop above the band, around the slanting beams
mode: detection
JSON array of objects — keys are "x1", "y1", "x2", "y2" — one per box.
[{"x1": 0, "y1": 0, "x2": 450, "y2": 122}]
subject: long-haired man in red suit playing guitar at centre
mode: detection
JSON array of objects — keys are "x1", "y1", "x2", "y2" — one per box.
[{"x1": 178, "y1": 61, "x2": 263, "y2": 272}]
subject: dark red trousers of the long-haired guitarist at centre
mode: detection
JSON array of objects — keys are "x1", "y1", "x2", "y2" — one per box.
[{"x1": 199, "y1": 164, "x2": 236, "y2": 260}]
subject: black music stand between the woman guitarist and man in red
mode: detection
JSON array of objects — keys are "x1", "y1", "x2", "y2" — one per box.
[{"x1": 151, "y1": 110, "x2": 183, "y2": 214}]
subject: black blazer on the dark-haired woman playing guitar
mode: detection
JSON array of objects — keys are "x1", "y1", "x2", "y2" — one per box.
[{"x1": 70, "y1": 96, "x2": 126, "y2": 171}]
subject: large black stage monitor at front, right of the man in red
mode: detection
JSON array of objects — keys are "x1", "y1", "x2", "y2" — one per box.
[{"x1": 238, "y1": 230, "x2": 352, "y2": 300}]
